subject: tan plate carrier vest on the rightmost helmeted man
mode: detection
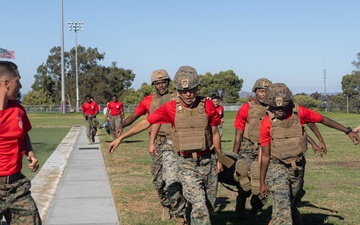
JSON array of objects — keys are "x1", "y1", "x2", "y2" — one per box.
[{"x1": 267, "y1": 104, "x2": 307, "y2": 171}]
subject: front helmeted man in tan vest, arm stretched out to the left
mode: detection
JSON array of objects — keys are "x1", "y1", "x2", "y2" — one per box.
[{"x1": 109, "y1": 66, "x2": 222, "y2": 224}]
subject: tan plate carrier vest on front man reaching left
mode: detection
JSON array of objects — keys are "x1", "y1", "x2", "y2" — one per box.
[{"x1": 172, "y1": 97, "x2": 213, "y2": 153}]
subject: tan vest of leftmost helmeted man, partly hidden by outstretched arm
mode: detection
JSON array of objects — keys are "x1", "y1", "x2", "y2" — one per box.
[{"x1": 149, "y1": 92, "x2": 176, "y2": 137}]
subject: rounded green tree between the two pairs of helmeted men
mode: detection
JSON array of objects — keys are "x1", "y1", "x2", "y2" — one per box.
[{"x1": 199, "y1": 70, "x2": 244, "y2": 103}]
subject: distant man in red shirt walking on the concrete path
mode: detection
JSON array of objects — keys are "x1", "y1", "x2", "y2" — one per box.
[{"x1": 82, "y1": 95, "x2": 100, "y2": 145}]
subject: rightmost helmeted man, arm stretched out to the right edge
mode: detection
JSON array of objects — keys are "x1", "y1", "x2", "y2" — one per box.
[{"x1": 260, "y1": 83, "x2": 359, "y2": 225}]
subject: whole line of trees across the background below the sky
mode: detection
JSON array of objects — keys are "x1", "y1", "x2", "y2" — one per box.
[{"x1": 22, "y1": 45, "x2": 360, "y2": 113}]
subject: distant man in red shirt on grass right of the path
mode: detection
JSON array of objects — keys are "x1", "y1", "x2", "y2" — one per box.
[{"x1": 105, "y1": 95, "x2": 125, "y2": 139}]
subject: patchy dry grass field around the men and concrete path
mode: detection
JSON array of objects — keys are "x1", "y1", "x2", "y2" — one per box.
[{"x1": 24, "y1": 112, "x2": 360, "y2": 225}]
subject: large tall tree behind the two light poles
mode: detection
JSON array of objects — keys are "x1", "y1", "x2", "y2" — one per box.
[{"x1": 24, "y1": 46, "x2": 135, "y2": 108}]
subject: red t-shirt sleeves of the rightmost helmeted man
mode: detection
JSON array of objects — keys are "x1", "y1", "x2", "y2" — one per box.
[{"x1": 260, "y1": 106, "x2": 322, "y2": 146}]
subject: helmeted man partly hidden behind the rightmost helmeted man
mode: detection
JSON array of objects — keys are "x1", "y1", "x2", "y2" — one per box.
[{"x1": 233, "y1": 78, "x2": 271, "y2": 222}]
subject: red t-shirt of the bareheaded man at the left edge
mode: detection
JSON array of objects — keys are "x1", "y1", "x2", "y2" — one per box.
[{"x1": 0, "y1": 101, "x2": 31, "y2": 176}]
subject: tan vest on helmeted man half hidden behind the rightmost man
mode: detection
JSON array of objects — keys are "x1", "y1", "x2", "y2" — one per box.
[{"x1": 243, "y1": 101, "x2": 267, "y2": 149}]
